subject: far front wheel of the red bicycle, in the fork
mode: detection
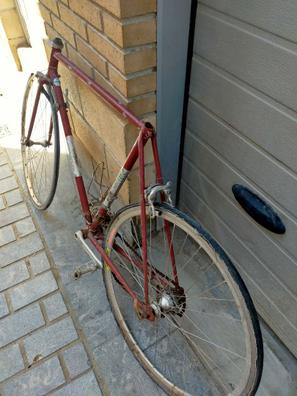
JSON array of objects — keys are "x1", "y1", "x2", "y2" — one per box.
[{"x1": 21, "y1": 74, "x2": 60, "y2": 210}]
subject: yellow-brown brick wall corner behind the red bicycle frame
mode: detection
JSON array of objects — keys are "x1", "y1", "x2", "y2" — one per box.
[{"x1": 40, "y1": 0, "x2": 156, "y2": 202}]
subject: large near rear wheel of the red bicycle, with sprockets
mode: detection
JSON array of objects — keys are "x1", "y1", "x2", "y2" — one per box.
[{"x1": 104, "y1": 205, "x2": 263, "y2": 396}]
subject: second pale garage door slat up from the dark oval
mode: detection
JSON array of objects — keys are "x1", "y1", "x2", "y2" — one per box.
[{"x1": 190, "y1": 57, "x2": 297, "y2": 171}]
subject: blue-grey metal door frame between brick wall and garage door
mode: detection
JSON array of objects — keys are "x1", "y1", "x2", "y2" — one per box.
[{"x1": 157, "y1": 0, "x2": 197, "y2": 203}]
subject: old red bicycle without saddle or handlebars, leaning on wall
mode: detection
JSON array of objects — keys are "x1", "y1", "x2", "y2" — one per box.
[{"x1": 21, "y1": 38, "x2": 263, "y2": 396}]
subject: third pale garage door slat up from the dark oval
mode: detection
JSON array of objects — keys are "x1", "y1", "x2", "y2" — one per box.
[{"x1": 194, "y1": 7, "x2": 297, "y2": 110}]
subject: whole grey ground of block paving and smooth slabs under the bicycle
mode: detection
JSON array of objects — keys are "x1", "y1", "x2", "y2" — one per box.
[{"x1": 0, "y1": 69, "x2": 297, "y2": 396}]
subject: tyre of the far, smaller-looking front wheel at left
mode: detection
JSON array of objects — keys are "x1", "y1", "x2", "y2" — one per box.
[{"x1": 21, "y1": 73, "x2": 60, "y2": 210}]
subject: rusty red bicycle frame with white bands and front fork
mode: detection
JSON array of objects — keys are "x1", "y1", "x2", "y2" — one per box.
[{"x1": 29, "y1": 38, "x2": 178, "y2": 318}]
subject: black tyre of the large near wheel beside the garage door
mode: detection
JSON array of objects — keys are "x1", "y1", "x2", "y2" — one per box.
[{"x1": 103, "y1": 204, "x2": 264, "y2": 396}]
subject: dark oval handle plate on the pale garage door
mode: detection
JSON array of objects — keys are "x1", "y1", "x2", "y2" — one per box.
[{"x1": 232, "y1": 184, "x2": 286, "y2": 234}]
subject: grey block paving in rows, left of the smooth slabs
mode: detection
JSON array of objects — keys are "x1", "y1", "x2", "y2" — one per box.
[{"x1": 0, "y1": 150, "x2": 100, "y2": 395}]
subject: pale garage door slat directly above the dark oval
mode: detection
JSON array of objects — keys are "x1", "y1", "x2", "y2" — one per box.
[{"x1": 186, "y1": 99, "x2": 297, "y2": 223}]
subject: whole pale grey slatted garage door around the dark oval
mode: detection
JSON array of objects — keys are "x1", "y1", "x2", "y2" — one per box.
[{"x1": 179, "y1": 0, "x2": 297, "y2": 356}]
